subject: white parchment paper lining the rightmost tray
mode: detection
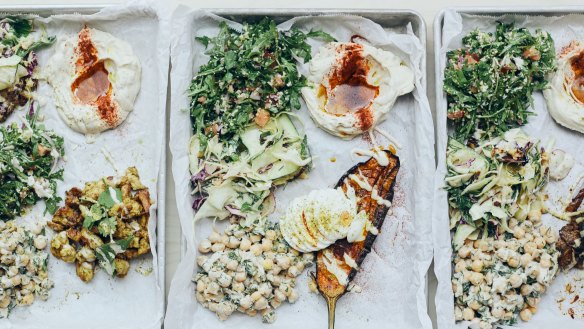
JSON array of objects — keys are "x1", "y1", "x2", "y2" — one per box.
[{"x1": 433, "y1": 11, "x2": 584, "y2": 329}]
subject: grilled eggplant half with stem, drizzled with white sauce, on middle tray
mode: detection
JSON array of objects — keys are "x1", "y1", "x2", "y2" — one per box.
[{"x1": 315, "y1": 151, "x2": 400, "y2": 328}]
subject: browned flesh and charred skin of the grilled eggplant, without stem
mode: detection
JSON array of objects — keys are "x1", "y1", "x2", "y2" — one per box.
[{"x1": 316, "y1": 151, "x2": 400, "y2": 299}]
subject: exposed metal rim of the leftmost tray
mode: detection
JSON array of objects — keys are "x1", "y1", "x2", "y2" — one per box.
[{"x1": 0, "y1": 3, "x2": 170, "y2": 326}]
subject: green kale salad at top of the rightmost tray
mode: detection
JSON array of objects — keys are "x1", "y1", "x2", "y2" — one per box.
[{"x1": 444, "y1": 23, "x2": 555, "y2": 142}]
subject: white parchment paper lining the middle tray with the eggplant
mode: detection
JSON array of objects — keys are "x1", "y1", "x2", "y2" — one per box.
[{"x1": 165, "y1": 7, "x2": 434, "y2": 329}]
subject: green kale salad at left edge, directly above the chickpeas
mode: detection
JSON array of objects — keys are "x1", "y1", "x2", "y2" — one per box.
[{"x1": 0, "y1": 111, "x2": 64, "y2": 221}]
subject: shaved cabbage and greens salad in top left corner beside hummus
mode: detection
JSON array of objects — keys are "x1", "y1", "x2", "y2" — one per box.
[{"x1": 0, "y1": 16, "x2": 55, "y2": 122}]
